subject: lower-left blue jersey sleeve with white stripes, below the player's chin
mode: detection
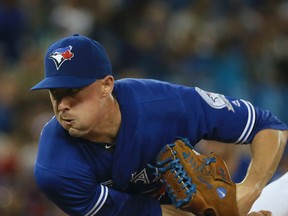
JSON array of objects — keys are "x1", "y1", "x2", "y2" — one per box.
[{"x1": 35, "y1": 164, "x2": 162, "y2": 216}]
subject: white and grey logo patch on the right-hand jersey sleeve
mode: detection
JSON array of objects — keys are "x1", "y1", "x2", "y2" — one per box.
[{"x1": 195, "y1": 87, "x2": 235, "y2": 112}]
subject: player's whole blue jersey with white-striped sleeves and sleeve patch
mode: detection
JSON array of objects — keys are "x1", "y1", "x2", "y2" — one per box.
[{"x1": 35, "y1": 79, "x2": 287, "y2": 216}]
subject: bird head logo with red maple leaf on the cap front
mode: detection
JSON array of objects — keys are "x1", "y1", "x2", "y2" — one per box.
[{"x1": 49, "y1": 45, "x2": 74, "y2": 70}]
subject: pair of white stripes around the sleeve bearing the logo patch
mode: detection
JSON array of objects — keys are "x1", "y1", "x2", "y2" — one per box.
[{"x1": 236, "y1": 100, "x2": 255, "y2": 143}]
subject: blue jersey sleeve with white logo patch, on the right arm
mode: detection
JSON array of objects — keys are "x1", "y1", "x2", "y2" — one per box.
[{"x1": 183, "y1": 87, "x2": 287, "y2": 144}]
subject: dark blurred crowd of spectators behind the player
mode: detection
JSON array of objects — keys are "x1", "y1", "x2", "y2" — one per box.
[{"x1": 0, "y1": 0, "x2": 288, "y2": 216}]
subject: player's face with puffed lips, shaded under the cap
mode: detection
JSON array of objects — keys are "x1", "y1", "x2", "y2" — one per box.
[{"x1": 49, "y1": 80, "x2": 105, "y2": 137}]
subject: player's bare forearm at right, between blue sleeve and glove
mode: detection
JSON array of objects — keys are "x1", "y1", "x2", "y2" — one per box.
[{"x1": 236, "y1": 129, "x2": 287, "y2": 216}]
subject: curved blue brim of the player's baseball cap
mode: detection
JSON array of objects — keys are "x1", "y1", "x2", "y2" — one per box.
[{"x1": 30, "y1": 76, "x2": 96, "y2": 91}]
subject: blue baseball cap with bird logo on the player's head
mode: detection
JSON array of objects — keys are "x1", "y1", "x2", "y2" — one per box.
[{"x1": 30, "y1": 34, "x2": 112, "y2": 91}]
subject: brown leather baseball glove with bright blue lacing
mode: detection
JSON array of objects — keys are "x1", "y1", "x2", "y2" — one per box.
[{"x1": 154, "y1": 139, "x2": 239, "y2": 216}]
